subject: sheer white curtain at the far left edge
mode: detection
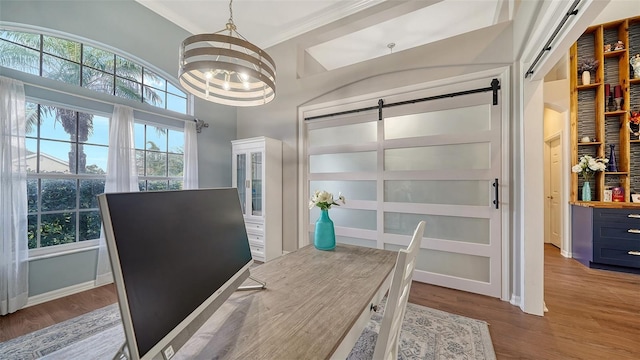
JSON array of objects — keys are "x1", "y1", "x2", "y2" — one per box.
[{"x1": 0, "y1": 77, "x2": 29, "y2": 315}]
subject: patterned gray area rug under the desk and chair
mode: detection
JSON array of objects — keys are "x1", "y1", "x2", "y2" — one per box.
[{"x1": 0, "y1": 303, "x2": 496, "y2": 360}]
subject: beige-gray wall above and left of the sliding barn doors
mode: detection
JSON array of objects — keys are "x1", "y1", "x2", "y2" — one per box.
[{"x1": 238, "y1": 2, "x2": 514, "y2": 251}]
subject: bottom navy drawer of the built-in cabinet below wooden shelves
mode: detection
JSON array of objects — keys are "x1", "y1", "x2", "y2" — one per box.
[{"x1": 593, "y1": 239, "x2": 640, "y2": 268}]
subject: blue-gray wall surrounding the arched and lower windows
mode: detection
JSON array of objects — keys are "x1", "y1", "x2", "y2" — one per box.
[{"x1": 0, "y1": 0, "x2": 237, "y2": 296}]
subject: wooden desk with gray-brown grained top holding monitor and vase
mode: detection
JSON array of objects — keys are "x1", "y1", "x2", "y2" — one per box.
[{"x1": 173, "y1": 244, "x2": 397, "y2": 360}]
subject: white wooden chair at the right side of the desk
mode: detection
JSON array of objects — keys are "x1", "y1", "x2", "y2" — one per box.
[{"x1": 373, "y1": 221, "x2": 425, "y2": 360}]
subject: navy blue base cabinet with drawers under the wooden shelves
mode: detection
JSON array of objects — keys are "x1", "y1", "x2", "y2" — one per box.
[{"x1": 571, "y1": 205, "x2": 640, "y2": 273}]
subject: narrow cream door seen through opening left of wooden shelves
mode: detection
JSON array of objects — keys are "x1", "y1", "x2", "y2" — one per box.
[{"x1": 548, "y1": 137, "x2": 562, "y2": 249}]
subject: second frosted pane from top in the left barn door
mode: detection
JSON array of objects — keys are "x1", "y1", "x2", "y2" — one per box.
[{"x1": 309, "y1": 151, "x2": 377, "y2": 173}]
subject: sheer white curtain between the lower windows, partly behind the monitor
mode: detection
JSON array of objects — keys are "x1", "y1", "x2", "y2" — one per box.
[{"x1": 96, "y1": 105, "x2": 139, "y2": 286}]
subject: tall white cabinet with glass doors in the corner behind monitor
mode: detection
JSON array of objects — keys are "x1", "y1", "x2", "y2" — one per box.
[{"x1": 231, "y1": 137, "x2": 282, "y2": 262}]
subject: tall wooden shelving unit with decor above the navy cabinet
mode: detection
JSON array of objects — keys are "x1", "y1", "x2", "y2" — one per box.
[{"x1": 570, "y1": 17, "x2": 640, "y2": 206}]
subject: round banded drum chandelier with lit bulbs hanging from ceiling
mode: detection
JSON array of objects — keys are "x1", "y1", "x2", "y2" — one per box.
[{"x1": 178, "y1": 0, "x2": 276, "y2": 106}]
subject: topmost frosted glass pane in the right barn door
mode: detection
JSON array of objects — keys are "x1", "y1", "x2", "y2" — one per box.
[{"x1": 384, "y1": 104, "x2": 491, "y2": 139}]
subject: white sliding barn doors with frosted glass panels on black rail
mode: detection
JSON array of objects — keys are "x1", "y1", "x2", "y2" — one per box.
[{"x1": 306, "y1": 86, "x2": 502, "y2": 297}]
